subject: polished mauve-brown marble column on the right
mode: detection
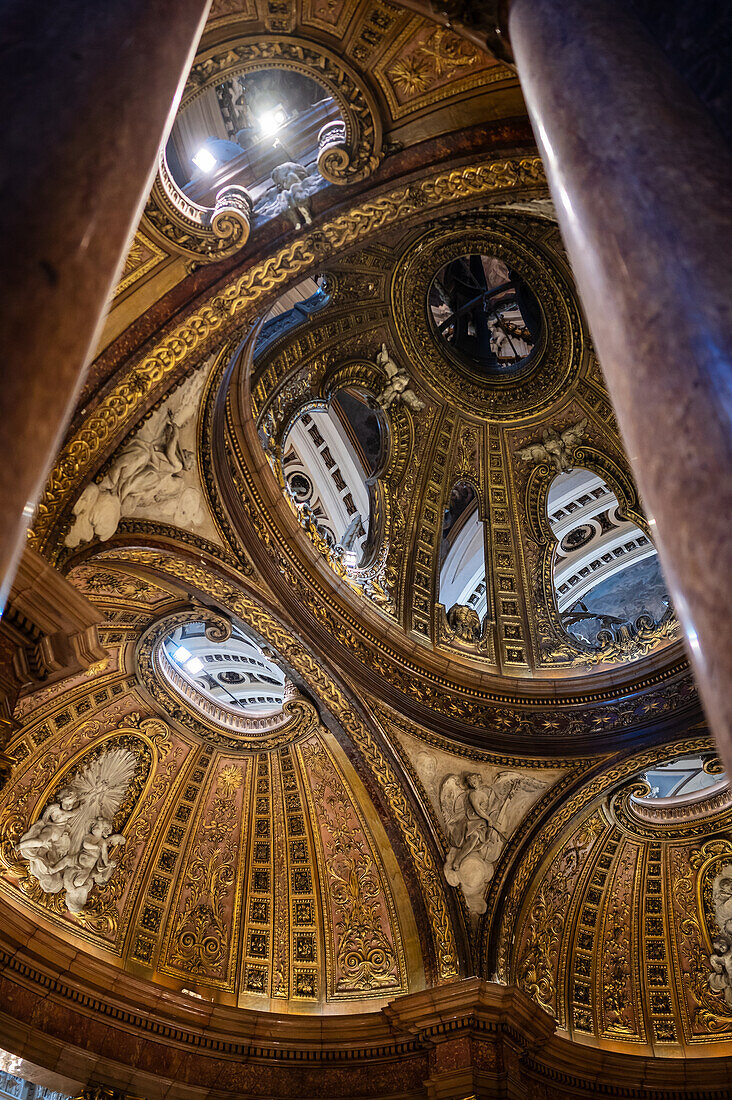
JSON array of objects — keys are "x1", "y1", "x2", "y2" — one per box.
[{"x1": 509, "y1": 0, "x2": 732, "y2": 774}]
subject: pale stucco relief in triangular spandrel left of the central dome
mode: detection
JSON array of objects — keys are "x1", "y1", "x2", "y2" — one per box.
[{"x1": 66, "y1": 371, "x2": 205, "y2": 547}]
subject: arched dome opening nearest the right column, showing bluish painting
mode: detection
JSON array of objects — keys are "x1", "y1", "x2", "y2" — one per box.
[{"x1": 547, "y1": 469, "x2": 669, "y2": 645}]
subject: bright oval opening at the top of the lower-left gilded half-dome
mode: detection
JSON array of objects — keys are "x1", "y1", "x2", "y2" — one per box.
[{"x1": 161, "y1": 623, "x2": 285, "y2": 717}]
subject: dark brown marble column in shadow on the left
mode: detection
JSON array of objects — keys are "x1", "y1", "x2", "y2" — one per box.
[{"x1": 0, "y1": 0, "x2": 210, "y2": 608}]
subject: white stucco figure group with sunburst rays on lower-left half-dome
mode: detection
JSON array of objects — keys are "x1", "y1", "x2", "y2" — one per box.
[{"x1": 15, "y1": 749, "x2": 136, "y2": 913}]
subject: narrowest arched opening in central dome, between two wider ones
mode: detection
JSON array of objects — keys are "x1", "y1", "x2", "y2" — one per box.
[{"x1": 439, "y1": 482, "x2": 488, "y2": 623}]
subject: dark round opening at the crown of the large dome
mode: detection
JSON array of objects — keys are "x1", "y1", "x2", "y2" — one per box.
[{"x1": 428, "y1": 253, "x2": 542, "y2": 377}]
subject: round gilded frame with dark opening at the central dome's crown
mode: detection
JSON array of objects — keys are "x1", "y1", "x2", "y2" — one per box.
[{"x1": 391, "y1": 215, "x2": 583, "y2": 420}]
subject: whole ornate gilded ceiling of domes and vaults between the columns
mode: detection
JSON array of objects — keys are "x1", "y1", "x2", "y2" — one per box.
[{"x1": 0, "y1": 0, "x2": 732, "y2": 1097}]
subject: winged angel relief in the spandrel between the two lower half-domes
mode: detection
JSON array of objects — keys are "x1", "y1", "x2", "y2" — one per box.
[{"x1": 439, "y1": 771, "x2": 545, "y2": 914}]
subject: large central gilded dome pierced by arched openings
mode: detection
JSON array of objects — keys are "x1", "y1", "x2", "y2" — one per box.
[{"x1": 206, "y1": 202, "x2": 684, "y2": 748}]
